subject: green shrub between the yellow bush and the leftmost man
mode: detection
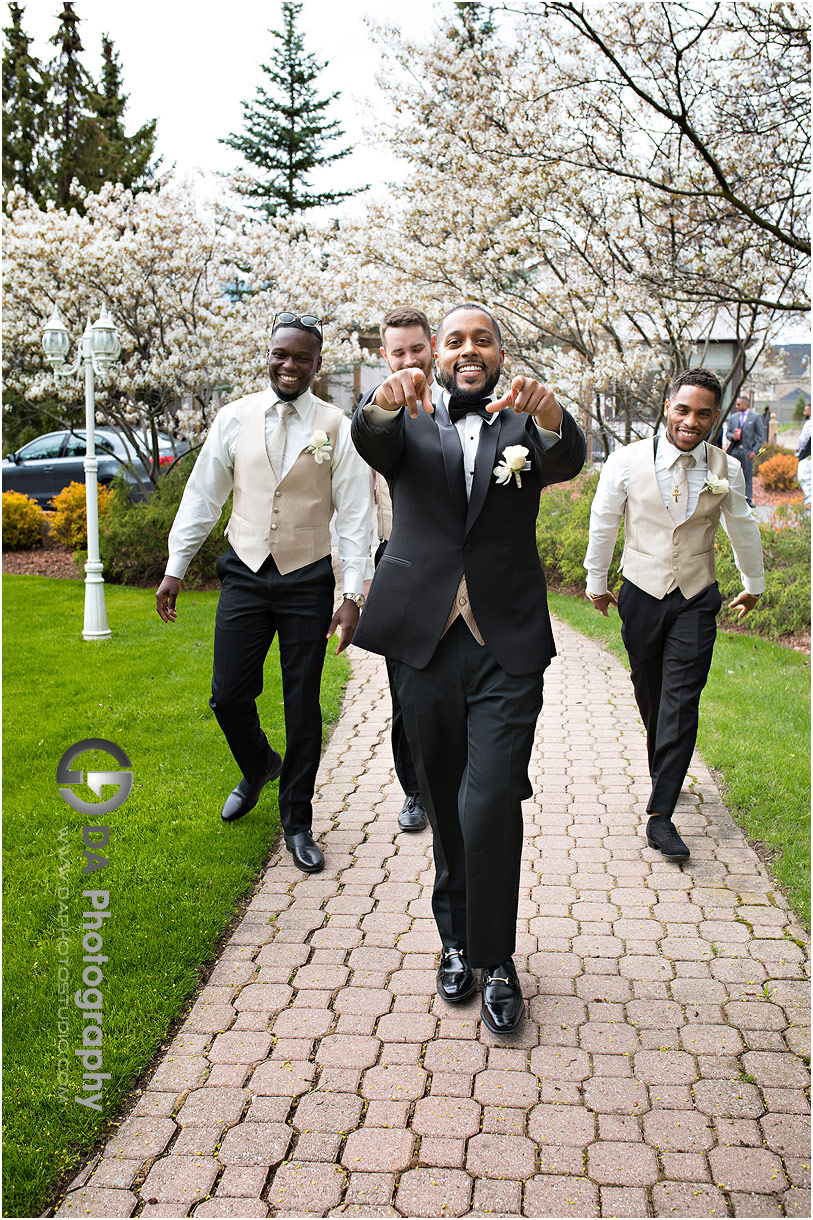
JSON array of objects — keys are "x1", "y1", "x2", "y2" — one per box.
[{"x1": 101, "y1": 454, "x2": 231, "y2": 588}]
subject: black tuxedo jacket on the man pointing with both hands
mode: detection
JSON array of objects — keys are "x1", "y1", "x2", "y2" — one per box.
[{"x1": 353, "y1": 394, "x2": 586, "y2": 675}]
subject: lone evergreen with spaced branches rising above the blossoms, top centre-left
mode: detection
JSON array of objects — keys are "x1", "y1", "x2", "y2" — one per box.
[{"x1": 220, "y1": 0, "x2": 354, "y2": 216}]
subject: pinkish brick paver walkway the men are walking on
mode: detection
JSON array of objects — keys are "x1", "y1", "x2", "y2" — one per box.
[{"x1": 59, "y1": 626, "x2": 811, "y2": 1216}]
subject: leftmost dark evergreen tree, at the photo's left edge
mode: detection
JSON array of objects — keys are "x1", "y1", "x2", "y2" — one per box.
[{"x1": 2, "y1": 4, "x2": 48, "y2": 204}]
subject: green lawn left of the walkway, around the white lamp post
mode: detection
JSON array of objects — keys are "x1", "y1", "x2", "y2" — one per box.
[{"x1": 2, "y1": 576, "x2": 348, "y2": 1216}]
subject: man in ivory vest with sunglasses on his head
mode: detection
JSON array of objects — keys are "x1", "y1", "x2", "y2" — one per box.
[{"x1": 156, "y1": 311, "x2": 371, "y2": 872}]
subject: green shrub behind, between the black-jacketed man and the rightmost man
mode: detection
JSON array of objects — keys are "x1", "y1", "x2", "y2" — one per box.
[{"x1": 536, "y1": 470, "x2": 624, "y2": 589}]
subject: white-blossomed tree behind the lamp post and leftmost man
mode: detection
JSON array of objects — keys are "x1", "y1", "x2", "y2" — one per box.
[{"x1": 2, "y1": 179, "x2": 360, "y2": 477}]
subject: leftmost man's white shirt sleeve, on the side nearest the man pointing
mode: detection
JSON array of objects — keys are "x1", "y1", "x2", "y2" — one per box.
[{"x1": 331, "y1": 417, "x2": 375, "y2": 593}]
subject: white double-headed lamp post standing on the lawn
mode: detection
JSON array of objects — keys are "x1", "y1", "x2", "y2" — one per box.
[{"x1": 43, "y1": 305, "x2": 121, "y2": 639}]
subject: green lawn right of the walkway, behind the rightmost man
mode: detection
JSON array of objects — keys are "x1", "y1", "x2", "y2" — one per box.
[{"x1": 549, "y1": 593, "x2": 811, "y2": 927}]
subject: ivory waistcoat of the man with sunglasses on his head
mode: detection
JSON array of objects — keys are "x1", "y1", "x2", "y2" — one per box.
[{"x1": 226, "y1": 394, "x2": 342, "y2": 576}]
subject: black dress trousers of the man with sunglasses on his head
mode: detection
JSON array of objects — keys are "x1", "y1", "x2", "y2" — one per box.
[{"x1": 209, "y1": 549, "x2": 336, "y2": 834}]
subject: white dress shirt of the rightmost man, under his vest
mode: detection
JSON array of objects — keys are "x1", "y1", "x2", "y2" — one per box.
[{"x1": 585, "y1": 436, "x2": 765, "y2": 597}]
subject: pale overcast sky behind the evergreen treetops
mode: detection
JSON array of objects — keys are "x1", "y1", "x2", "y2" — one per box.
[{"x1": 15, "y1": 0, "x2": 436, "y2": 189}]
